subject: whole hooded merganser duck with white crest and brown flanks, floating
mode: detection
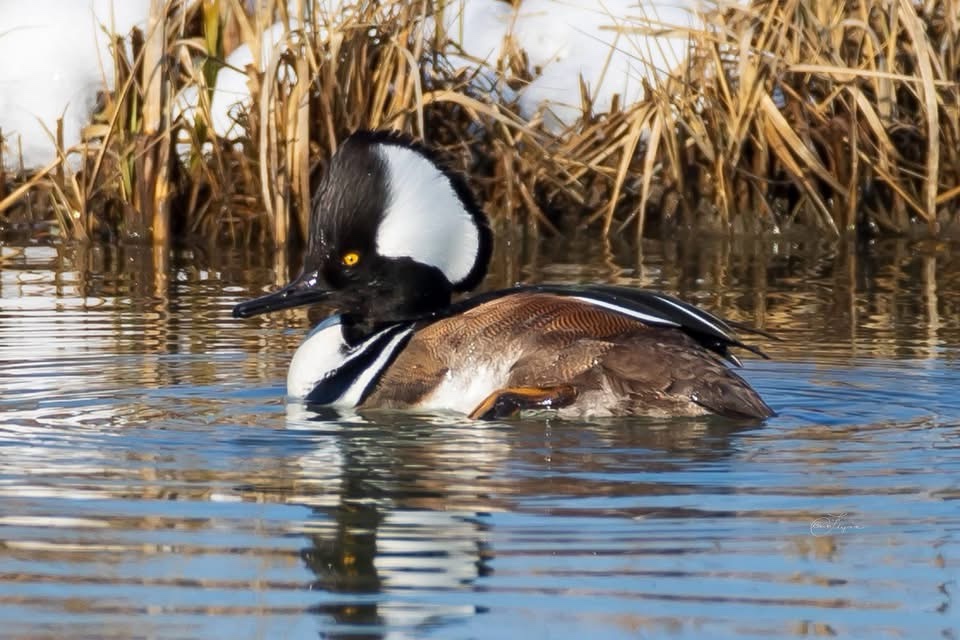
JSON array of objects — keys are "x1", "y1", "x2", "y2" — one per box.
[{"x1": 233, "y1": 130, "x2": 774, "y2": 420}]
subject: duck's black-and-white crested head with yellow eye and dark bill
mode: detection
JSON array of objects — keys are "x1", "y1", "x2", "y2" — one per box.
[{"x1": 233, "y1": 132, "x2": 491, "y2": 326}]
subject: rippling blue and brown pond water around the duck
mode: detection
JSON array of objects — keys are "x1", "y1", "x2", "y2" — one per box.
[{"x1": 0, "y1": 238, "x2": 960, "y2": 638}]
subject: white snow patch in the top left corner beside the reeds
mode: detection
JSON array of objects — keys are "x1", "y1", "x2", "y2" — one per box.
[{"x1": 0, "y1": 0, "x2": 150, "y2": 168}]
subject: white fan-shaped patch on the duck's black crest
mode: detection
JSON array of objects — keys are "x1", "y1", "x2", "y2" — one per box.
[{"x1": 377, "y1": 144, "x2": 480, "y2": 284}]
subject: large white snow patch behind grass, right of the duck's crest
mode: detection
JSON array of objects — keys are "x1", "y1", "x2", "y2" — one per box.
[{"x1": 432, "y1": 0, "x2": 699, "y2": 131}]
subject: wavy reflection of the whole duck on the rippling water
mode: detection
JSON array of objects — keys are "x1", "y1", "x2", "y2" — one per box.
[{"x1": 287, "y1": 407, "x2": 751, "y2": 638}]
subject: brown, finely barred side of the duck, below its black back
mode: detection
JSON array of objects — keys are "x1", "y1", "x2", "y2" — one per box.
[{"x1": 363, "y1": 290, "x2": 772, "y2": 418}]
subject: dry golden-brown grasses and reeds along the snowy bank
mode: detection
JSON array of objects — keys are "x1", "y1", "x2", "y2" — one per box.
[{"x1": 0, "y1": 0, "x2": 960, "y2": 246}]
